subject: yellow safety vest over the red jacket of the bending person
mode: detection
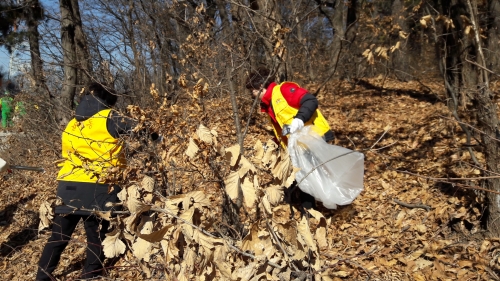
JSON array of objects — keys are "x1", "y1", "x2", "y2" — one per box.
[{"x1": 271, "y1": 82, "x2": 330, "y2": 148}]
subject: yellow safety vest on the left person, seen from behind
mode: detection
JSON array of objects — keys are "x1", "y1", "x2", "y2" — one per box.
[{"x1": 57, "y1": 109, "x2": 126, "y2": 183}]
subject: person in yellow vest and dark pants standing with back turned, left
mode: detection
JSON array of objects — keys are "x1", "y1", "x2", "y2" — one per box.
[{"x1": 36, "y1": 83, "x2": 153, "y2": 280}]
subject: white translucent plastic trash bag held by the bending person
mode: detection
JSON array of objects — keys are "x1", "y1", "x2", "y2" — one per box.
[{"x1": 288, "y1": 126, "x2": 364, "y2": 209}]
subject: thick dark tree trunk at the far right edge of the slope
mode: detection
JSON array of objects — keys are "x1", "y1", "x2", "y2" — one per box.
[{"x1": 434, "y1": 0, "x2": 500, "y2": 237}]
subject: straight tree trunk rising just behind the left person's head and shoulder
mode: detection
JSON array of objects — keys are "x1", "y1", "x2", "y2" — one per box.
[{"x1": 58, "y1": 0, "x2": 77, "y2": 124}]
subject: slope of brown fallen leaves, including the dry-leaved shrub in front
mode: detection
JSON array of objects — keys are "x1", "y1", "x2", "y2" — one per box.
[{"x1": 0, "y1": 80, "x2": 500, "y2": 280}]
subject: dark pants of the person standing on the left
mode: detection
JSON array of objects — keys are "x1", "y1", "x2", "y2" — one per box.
[{"x1": 36, "y1": 215, "x2": 109, "y2": 280}]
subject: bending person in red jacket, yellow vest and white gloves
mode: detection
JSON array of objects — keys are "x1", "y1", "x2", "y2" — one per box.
[{"x1": 245, "y1": 67, "x2": 334, "y2": 209}]
